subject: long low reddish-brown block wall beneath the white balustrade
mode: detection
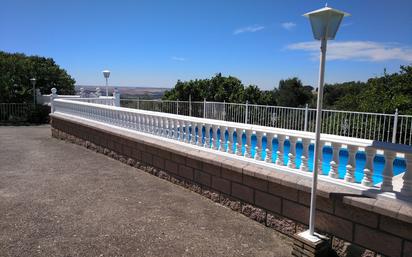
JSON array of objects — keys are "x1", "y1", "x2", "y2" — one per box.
[{"x1": 52, "y1": 115, "x2": 412, "y2": 257}]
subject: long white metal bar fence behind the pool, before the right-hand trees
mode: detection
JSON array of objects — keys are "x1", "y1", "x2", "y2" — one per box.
[{"x1": 121, "y1": 99, "x2": 412, "y2": 145}]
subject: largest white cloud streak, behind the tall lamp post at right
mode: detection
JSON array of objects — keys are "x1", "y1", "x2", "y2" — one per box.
[{"x1": 286, "y1": 41, "x2": 412, "y2": 62}]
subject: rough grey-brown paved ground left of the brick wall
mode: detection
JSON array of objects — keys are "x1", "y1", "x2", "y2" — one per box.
[{"x1": 0, "y1": 126, "x2": 291, "y2": 256}]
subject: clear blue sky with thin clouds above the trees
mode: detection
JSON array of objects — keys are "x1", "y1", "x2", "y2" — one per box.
[{"x1": 0, "y1": 0, "x2": 412, "y2": 89}]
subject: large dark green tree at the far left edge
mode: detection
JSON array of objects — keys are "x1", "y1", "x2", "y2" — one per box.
[{"x1": 0, "y1": 51, "x2": 75, "y2": 102}]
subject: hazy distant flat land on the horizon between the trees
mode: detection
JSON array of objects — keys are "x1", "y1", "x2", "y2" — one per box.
[{"x1": 75, "y1": 85, "x2": 170, "y2": 99}]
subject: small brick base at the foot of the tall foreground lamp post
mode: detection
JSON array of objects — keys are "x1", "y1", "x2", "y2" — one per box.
[{"x1": 292, "y1": 230, "x2": 332, "y2": 257}]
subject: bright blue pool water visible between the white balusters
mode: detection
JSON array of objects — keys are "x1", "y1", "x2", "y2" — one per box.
[{"x1": 182, "y1": 128, "x2": 406, "y2": 184}]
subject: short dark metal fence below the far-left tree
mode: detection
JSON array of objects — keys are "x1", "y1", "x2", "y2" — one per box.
[{"x1": 0, "y1": 103, "x2": 33, "y2": 123}]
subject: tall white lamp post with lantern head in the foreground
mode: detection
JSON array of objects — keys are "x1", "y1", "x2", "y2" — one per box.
[{"x1": 304, "y1": 6, "x2": 349, "y2": 236}]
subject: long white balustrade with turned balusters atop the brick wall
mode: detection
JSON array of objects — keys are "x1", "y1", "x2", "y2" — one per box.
[{"x1": 53, "y1": 99, "x2": 412, "y2": 196}]
